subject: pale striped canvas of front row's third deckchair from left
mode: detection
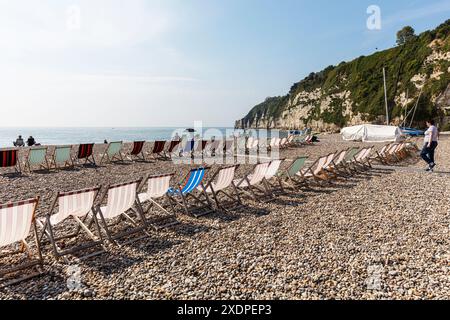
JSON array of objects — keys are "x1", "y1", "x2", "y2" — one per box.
[{"x1": 100, "y1": 181, "x2": 140, "y2": 219}]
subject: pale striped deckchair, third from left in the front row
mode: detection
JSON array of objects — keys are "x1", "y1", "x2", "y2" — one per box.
[{"x1": 96, "y1": 179, "x2": 148, "y2": 245}]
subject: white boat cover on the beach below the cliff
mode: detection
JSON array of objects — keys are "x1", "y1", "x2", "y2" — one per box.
[{"x1": 341, "y1": 124, "x2": 403, "y2": 142}]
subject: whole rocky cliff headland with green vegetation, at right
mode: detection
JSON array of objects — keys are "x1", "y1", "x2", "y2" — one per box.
[{"x1": 236, "y1": 20, "x2": 450, "y2": 131}]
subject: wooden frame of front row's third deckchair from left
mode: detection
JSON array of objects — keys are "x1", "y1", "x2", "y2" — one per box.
[{"x1": 95, "y1": 179, "x2": 150, "y2": 247}]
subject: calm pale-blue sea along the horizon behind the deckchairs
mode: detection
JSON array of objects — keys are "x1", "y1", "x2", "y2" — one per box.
[{"x1": 0, "y1": 128, "x2": 276, "y2": 148}]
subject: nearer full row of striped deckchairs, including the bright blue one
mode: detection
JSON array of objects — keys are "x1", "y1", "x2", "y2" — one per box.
[{"x1": 0, "y1": 143, "x2": 414, "y2": 283}]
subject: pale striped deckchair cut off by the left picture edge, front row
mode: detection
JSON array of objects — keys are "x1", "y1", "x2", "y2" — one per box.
[{"x1": 0, "y1": 197, "x2": 43, "y2": 286}]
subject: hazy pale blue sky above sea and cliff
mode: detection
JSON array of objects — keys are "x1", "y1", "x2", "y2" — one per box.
[{"x1": 0, "y1": 0, "x2": 450, "y2": 126}]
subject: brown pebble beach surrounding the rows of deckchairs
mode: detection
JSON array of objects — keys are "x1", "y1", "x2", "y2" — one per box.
[{"x1": 0, "y1": 135, "x2": 450, "y2": 300}]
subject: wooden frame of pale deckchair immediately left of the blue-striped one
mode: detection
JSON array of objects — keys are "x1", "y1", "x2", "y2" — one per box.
[{"x1": 138, "y1": 173, "x2": 180, "y2": 231}]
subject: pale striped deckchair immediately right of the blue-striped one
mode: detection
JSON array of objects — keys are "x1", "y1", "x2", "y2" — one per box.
[{"x1": 202, "y1": 165, "x2": 242, "y2": 211}]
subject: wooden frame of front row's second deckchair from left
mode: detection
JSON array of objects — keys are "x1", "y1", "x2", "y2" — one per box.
[{"x1": 38, "y1": 187, "x2": 106, "y2": 263}]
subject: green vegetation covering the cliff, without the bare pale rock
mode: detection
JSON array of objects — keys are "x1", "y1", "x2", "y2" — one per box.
[{"x1": 238, "y1": 20, "x2": 450, "y2": 127}]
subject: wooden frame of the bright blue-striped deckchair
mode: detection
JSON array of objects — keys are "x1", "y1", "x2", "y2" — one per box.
[{"x1": 168, "y1": 167, "x2": 215, "y2": 218}]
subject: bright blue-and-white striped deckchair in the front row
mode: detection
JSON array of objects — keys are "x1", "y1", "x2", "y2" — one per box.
[{"x1": 167, "y1": 168, "x2": 214, "y2": 218}]
